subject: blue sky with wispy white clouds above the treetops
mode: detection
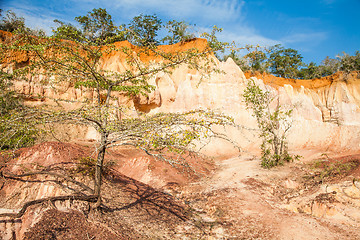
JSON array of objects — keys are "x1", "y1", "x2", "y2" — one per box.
[{"x1": 0, "y1": 0, "x2": 360, "y2": 63}]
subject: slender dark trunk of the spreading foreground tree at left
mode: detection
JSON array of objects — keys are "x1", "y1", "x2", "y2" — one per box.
[{"x1": 94, "y1": 132, "x2": 107, "y2": 208}]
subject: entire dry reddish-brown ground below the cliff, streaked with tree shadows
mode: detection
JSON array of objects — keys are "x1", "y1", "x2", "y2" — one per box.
[{"x1": 0, "y1": 143, "x2": 360, "y2": 240}]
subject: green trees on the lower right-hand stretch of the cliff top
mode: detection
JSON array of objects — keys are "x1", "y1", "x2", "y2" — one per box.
[{"x1": 223, "y1": 45, "x2": 360, "y2": 79}]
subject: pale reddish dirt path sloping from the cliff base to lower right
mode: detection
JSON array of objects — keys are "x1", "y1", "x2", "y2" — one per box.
[{"x1": 183, "y1": 153, "x2": 360, "y2": 240}]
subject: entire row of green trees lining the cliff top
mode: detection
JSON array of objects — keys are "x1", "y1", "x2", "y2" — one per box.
[{"x1": 0, "y1": 8, "x2": 360, "y2": 79}]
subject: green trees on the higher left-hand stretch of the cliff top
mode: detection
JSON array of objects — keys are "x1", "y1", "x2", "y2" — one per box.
[{"x1": 0, "y1": 8, "x2": 197, "y2": 46}]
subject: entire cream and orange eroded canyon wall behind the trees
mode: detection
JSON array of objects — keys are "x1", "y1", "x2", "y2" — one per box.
[{"x1": 2, "y1": 32, "x2": 360, "y2": 157}]
